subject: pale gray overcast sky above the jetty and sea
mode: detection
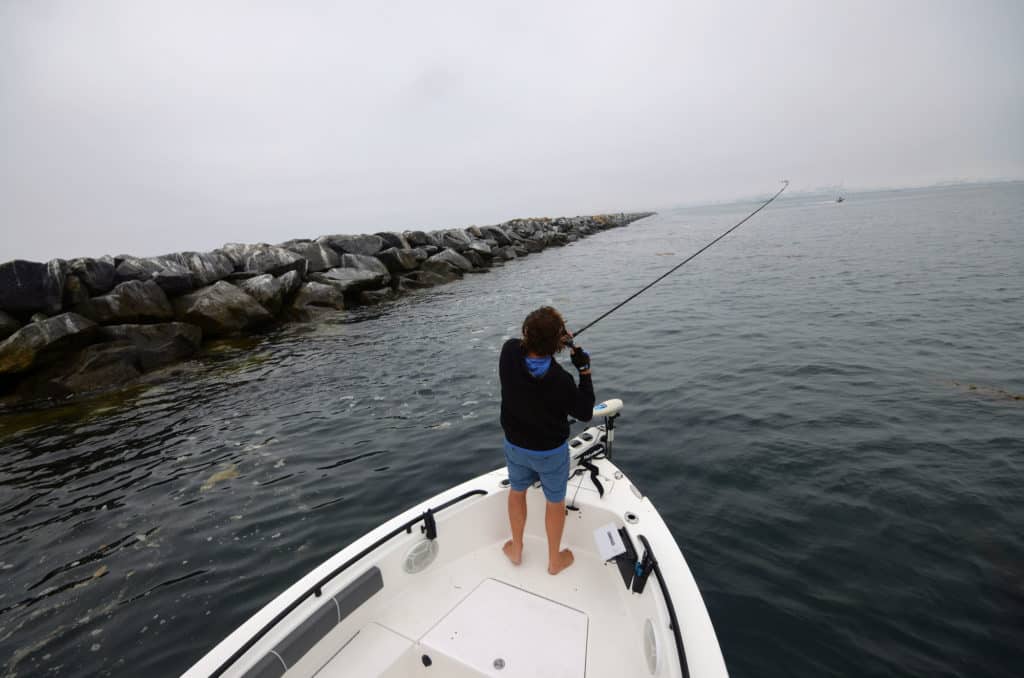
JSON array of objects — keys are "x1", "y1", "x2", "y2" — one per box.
[{"x1": 0, "y1": 0, "x2": 1024, "y2": 261}]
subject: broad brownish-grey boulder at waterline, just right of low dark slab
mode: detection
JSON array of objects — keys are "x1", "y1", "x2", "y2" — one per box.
[{"x1": 174, "y1": 281, "x2": 273, "y2": 337}]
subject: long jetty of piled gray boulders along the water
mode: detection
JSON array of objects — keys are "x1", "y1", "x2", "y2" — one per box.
[{"x1": 0, "y1": 212, "x2": 651, "y2": 400}]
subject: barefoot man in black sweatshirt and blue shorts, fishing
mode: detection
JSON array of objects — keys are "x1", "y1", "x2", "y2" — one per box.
[{"x1": 498, "y1": 306, "x2": 594, "y2": 575}]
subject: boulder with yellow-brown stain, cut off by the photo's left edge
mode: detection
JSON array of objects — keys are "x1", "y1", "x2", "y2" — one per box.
[{"x1": 0, "y1": 313, "x2": 97, "y2": 375}]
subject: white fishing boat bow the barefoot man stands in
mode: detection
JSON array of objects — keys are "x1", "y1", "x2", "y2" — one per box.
[{"x1": 184, "y1": 400, "x2": 727, "y2": 678}]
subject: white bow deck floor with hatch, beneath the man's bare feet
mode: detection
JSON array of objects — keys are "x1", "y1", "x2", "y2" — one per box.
[{"x1": 285, "y1": 492, "x2": 647, "y2": 678}]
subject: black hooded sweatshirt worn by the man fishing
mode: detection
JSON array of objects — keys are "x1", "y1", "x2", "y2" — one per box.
[{"x1": 498, "y1": 339, "x2": 594, "y2": 451}]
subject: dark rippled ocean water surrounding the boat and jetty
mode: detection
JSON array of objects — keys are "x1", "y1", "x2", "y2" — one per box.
[{"x1": 0, "y1": 183, "x2": 1024, "y2": 677}]
